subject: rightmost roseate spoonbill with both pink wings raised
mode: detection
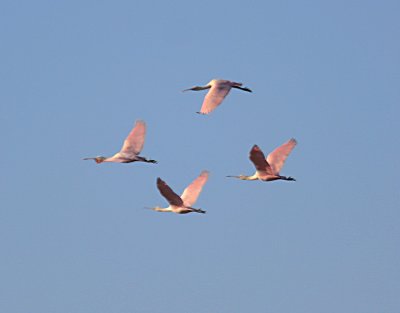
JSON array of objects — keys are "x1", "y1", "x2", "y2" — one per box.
[{"x1": 227, "y1": 138, "x2": 297, "y2": 181}]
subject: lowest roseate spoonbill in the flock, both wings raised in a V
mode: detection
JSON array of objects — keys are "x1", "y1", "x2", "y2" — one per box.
[{"x1": 152, "y1": 171, "x2": 209, "y2": 214}]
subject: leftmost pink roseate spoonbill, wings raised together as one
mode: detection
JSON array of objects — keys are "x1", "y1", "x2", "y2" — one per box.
[{"x1": 84, "y1": 121, "x2": 157, "y2": 163}]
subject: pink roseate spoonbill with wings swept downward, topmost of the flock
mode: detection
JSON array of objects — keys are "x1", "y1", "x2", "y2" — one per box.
[{"x1": 184, "y1": 79, "x2": 252, "y2": 114}]
